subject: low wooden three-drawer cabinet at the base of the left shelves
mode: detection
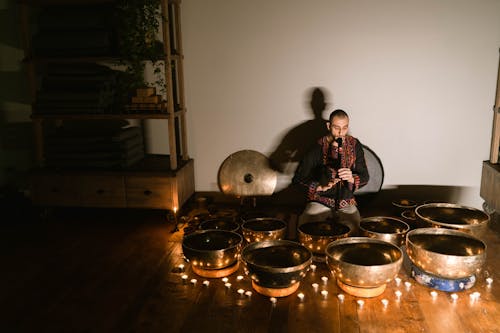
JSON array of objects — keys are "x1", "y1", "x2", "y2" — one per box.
[{"x1": 32, "y1": 156, "x2": 194, "y2": 210}]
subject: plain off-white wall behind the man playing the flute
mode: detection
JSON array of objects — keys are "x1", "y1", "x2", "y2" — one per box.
[{"x1": 155, "y1": 0, "x2": 500, "y2": 206}]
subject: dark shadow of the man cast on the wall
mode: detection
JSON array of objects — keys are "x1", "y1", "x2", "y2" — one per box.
[{"x1": 269, "y1": 87, "x2": 329, "y2": 204}]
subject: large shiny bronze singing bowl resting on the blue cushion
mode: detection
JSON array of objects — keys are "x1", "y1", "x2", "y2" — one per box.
[{"x1": 406, "y1": 228, "x2": 486, "y2": 279}]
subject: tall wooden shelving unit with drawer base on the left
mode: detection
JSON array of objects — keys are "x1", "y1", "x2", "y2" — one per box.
[{"x1": 20, "y1": 0, "x2": 194, "y2": 210}]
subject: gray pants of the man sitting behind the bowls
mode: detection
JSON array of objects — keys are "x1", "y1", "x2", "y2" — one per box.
[{"x1": 298, "y1": 202, "x2": 361, "y2": 235}]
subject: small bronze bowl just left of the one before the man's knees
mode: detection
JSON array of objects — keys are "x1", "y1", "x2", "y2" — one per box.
[{"x1": 241, "y1": 217, "x2": 287, "y2": 243}]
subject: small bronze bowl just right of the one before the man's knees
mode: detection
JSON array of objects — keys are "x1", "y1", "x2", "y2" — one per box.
[{"x1": 359, "y1": 216, "x2": 410, "y2": 246}]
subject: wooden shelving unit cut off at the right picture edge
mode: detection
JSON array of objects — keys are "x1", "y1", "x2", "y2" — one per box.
[{"x1": 480, "y1": 48, "x2": 500, "y2": 212}]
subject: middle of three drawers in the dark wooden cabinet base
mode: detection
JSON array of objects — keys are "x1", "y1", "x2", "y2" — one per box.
[{"x1": 80, "y1": 176, "x2": 126, "y2": 207}]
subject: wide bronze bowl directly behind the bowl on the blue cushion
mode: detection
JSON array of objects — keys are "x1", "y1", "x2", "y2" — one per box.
[{"x1": 415, "y1": 203, "x2": 490, "y2": 237}]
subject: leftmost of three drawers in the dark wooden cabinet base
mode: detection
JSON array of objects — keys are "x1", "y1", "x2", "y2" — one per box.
[{"x1": 32, "y1": 174, "x2": 81, "y2": 206}]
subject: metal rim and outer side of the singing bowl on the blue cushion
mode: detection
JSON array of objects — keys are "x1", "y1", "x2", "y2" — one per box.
[{"x1": 406, "y1": 227, "x2": 487, "y2": 279}]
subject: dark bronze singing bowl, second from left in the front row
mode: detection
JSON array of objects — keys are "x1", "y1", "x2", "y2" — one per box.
[{"x1": 241, "y1": 240, "x2": 312, "y2": 289}]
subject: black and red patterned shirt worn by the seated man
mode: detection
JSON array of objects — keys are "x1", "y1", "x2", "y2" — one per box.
[{"x1": 293, "y1": 135, "x2": 369, "y2": 208}]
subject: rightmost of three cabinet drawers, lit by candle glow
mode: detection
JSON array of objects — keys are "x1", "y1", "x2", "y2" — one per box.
[{"x1": 125, "y1": 176, "x2": 177, "y2": 209}]
